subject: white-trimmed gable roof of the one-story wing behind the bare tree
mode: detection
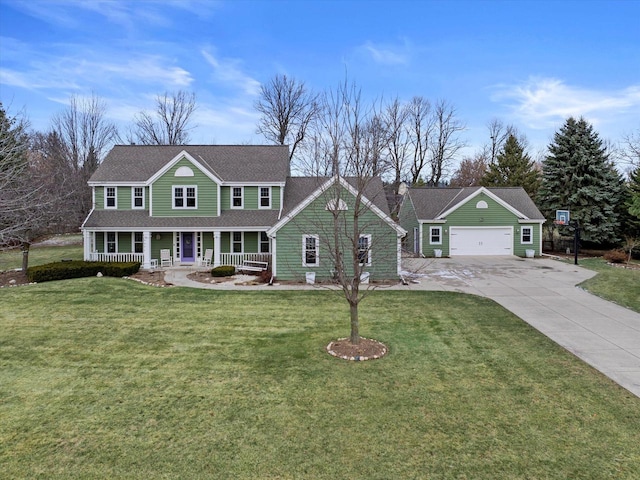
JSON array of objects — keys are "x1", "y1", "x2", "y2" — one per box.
[{"x1": 267, "y1": 176, "x2": 407, "y2": 235}]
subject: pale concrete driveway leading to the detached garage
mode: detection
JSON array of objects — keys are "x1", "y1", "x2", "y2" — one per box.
[{"x1": 404, "y1": 257, "x2": 640, "y2": 397}]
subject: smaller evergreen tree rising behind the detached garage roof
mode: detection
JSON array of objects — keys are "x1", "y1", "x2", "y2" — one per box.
[{"x1": 481, "y1": 135, "x2": 540, "y2": 197}]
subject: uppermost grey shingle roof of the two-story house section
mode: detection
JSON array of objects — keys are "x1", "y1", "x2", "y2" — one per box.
[{"x1": 89, "y1": 145, "x2": 289, "y2": 183}]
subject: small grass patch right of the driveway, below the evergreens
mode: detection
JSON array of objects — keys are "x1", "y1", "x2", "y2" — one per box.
[{"x1": 579, "y1": 258, "x2": 640, "y2": 312}]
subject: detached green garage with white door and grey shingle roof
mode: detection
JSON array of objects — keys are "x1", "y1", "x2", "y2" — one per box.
[{"x1": 399, "y1": 187, "x2": 545, "y2": 257}]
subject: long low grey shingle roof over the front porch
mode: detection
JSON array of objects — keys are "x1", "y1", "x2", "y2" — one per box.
[{"x1": 84, "y1": 210, "x2": 278, "y2": 230}]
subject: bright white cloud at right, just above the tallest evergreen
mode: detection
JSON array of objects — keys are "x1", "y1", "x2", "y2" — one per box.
[{"x1": 491, "y1": 78, "x2": 640, "y2": 129}]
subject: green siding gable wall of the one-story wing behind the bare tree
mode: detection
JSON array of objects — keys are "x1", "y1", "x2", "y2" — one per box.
[{"x1": 276, "y1": 185, "x2": 398, "y2": 280}]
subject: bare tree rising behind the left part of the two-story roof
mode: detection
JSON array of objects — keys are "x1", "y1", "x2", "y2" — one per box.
[{"x1": 127, "y1": 90, "x2": 197, "y2": 145}]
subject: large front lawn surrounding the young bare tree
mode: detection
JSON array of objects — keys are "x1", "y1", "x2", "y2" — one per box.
[{"x1": 0, "y1": 278, "x2": 640, "y2": 480}]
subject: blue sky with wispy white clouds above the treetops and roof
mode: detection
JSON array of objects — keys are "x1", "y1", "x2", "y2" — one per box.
[{"x1": 0, "y1": 0, "x2": 640, "y2": 166}]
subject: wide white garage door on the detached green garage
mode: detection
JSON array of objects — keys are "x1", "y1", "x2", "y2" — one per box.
[{"x1": 450, "y1": 227, "x2": 513, "y2": 257}]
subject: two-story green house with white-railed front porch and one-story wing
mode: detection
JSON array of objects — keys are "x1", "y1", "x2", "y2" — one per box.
[{"x1": 82, "y1": 145, "x2": 402, "y2": 279}]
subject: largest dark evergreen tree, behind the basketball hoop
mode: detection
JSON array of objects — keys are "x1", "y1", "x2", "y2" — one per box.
[{"x1": 538, "y1": 118, "x2": 623, "y2": 245}]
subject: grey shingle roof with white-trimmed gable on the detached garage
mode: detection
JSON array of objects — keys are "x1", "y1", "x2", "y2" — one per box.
[{"x1": 405, "y1": 187, "x2": 545, "y2": 220}]
